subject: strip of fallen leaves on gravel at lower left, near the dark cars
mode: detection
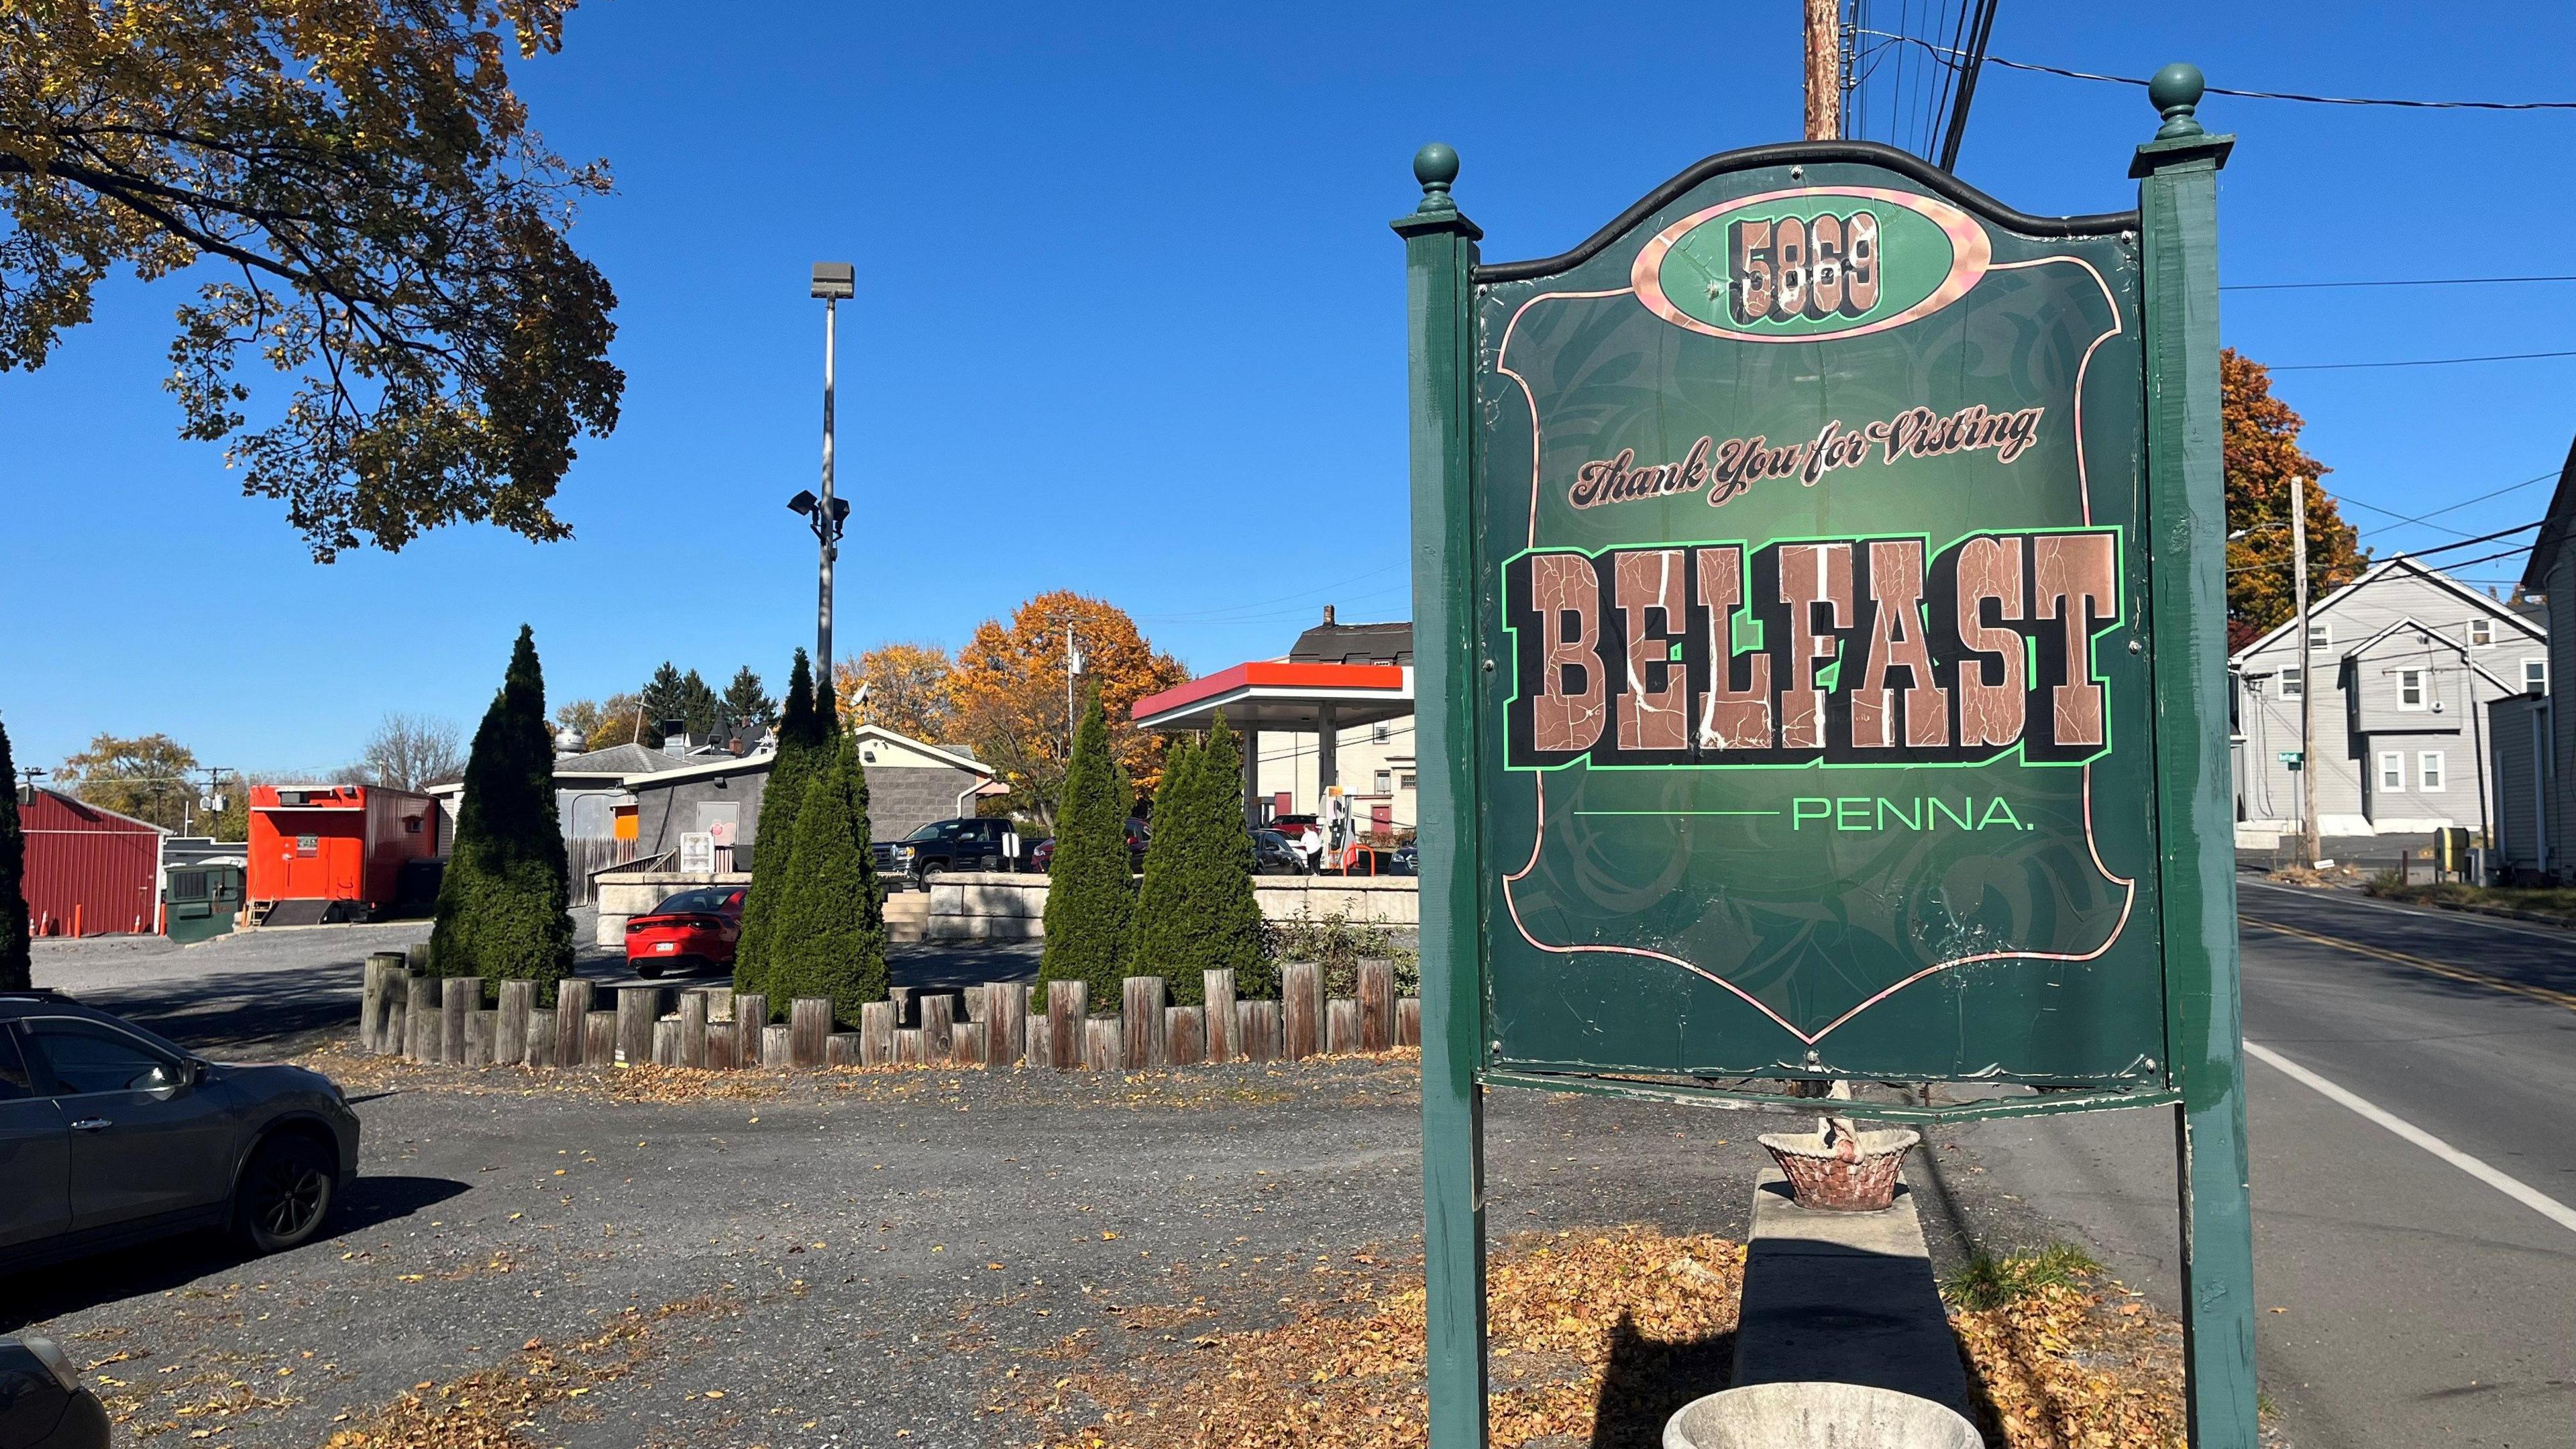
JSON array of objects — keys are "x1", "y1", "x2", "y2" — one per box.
[{"x1": 325, "y1": 1297, "x2": 732, "y2": 1449}]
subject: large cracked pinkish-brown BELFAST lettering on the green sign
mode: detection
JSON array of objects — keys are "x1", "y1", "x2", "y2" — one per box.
[{"x1": 1505, "y1": 529, "x2": 2120, "y2": 768}]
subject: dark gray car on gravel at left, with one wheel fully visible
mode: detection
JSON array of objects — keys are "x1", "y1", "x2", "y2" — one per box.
[{"x1": 0, "y1": 990, "x2": 358, "y2": 1271}]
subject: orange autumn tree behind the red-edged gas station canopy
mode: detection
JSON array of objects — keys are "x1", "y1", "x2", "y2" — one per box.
[{"x1": 951, "y1": 588, "x2": 1190, "y2": 828}]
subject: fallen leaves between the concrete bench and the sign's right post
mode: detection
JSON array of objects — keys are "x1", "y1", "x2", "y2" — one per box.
[{"x1": 1950, "y1": 1274, "x2": 2184, "y2": 1449}]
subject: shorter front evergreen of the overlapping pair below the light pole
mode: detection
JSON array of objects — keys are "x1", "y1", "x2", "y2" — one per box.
[{"x1": 767, "y1": 735, "x2": 886, "y2": 1029}]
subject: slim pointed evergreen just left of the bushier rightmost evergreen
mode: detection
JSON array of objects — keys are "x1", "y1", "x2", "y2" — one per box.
[{"x1": 1038, "y1": 686, "x2": 1136, "y2": 1006}]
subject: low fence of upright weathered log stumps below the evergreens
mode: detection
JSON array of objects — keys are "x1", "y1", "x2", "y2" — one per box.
[{"x1": 358, "y1": 947, "x2": 1422, "y2": 1070}]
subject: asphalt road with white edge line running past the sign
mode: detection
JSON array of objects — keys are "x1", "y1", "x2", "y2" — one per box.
[{"x1": 1929, "y1": 879, "x2": 2576, "y2": 1449}]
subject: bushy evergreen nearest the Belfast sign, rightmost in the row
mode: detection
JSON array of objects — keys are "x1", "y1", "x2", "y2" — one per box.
[{"x1": 1128, "y1": 714, "x2": 1275, "y2": 1006}]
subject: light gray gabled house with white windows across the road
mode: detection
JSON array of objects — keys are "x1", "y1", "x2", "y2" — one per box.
[{"x1": 2229, "y1": 554, "x2": 2551, "y2": 848}]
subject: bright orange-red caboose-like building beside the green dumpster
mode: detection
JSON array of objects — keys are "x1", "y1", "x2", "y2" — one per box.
[{"x1": 245, "y1": 784, "x2": 438, "y2": 920}]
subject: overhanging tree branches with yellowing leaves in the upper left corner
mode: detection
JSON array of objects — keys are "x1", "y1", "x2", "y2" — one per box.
[{"x1": 0, "y1": 0, "x2": 626, "y2": 559}]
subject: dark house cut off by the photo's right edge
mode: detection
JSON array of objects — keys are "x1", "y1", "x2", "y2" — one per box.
[{"x1": 2486, "y1": 433, "x2": 2576, "y2": 881}]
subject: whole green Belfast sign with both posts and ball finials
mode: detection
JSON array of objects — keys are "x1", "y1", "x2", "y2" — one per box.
[{"x1": 1393, "y1": 67, "x2": 2254, "y2": 1449}]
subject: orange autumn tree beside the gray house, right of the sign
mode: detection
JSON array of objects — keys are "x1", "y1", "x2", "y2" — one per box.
[{"x1": 2218, "y1": 348, "x2": 2370, "y2": 650}]
